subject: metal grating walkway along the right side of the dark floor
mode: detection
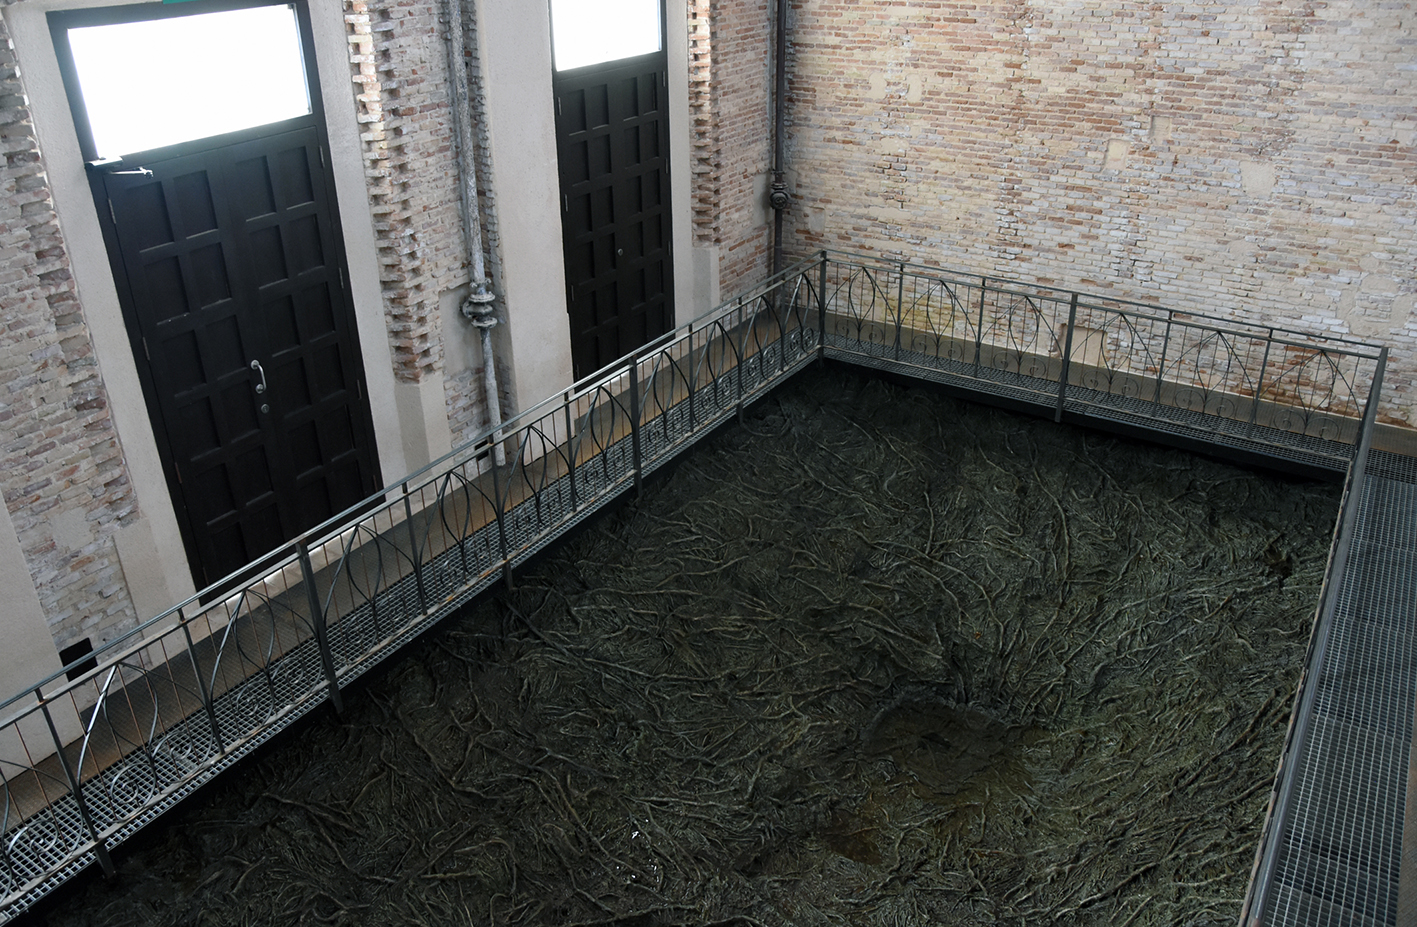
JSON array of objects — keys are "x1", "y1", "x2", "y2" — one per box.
[{"x1": 1258, "y1": 451, "x2": 1417, "y2": 927}]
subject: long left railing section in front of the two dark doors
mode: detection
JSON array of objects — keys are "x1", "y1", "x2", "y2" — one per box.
[{"x1": 0, "y1": 257, "x2": 822, "y2": 920}]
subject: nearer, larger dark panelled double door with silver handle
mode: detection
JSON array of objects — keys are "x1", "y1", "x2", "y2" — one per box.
[{"x1": 95, "y1": 126, "x2": 380, "y2": 585}]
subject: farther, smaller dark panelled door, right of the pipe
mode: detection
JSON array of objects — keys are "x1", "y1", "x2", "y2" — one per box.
[{"x1": 554, "y1": 51, "x2": 674, "y2": 378}]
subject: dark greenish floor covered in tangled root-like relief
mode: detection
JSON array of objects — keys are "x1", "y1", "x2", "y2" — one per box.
[{"x1": 35, "y1": 370, "x2": 1338, "y2": 927}]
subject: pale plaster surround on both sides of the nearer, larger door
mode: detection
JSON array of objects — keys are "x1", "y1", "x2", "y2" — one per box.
[{"x1": 0, "y1": 0, "x2": 417, "y2": 619}]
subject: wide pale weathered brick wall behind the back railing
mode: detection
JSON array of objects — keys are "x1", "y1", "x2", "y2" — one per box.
[{"x1": 789, "y1": 0, "x2": 1417, "y2": 424}]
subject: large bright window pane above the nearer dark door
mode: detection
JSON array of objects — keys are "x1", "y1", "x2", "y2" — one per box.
[{"x1": 68, "y1": 6, "x2": 310, "y2": 157}]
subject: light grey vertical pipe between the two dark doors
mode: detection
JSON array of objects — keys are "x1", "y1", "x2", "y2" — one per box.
[{"x1": 445, "y1": 0, "x2": 506, "y2": 466}]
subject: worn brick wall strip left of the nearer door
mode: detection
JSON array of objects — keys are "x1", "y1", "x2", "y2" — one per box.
[{"x1": 0, "y1": 20, "x2": 137, "y2": 648}]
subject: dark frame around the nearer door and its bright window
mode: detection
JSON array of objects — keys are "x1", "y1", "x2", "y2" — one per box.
[{"x1": 45, "y1": 0, "x2": 383, "y2": 590}]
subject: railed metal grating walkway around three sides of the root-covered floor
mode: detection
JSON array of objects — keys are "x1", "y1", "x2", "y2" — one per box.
[{"x1": 0, "y1": 252, "x2": 1417, "y2": 927}]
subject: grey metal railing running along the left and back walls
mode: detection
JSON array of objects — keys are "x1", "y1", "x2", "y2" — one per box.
[{"x1": 0, "y1": 252, "x2": 1384, "y2": 920}]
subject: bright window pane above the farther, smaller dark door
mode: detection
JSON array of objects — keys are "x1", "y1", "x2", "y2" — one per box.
[{"x1": 551, "y1": 0, "x2": 660, "y2": 71}]
